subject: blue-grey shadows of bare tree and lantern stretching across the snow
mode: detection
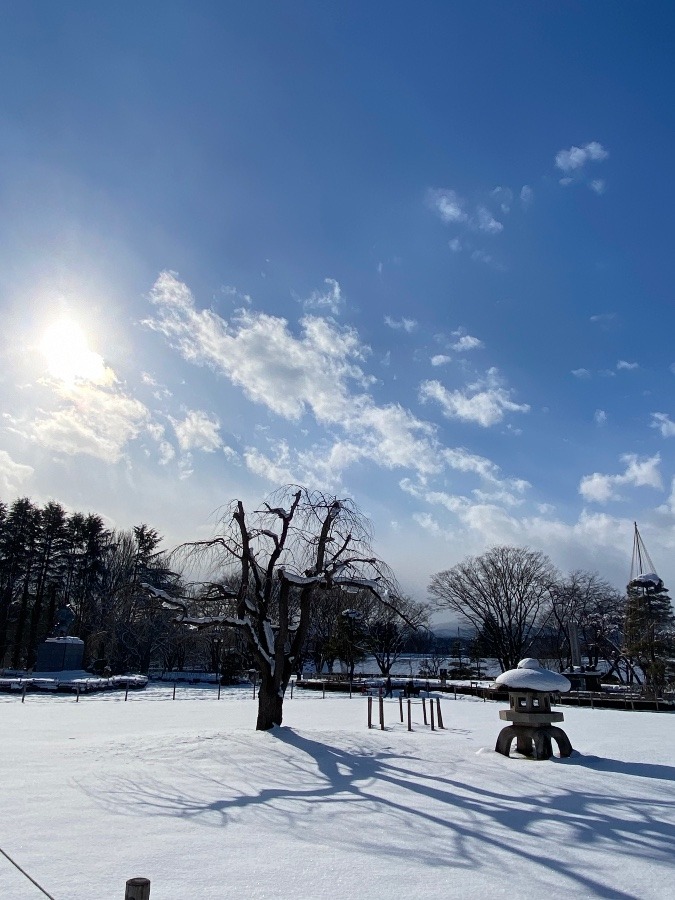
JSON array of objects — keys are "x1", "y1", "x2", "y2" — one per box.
[{"x1": 83, "y1": 727, "x2": 675, "y2": 900}]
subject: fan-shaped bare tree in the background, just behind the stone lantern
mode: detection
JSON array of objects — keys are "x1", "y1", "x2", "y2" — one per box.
[{"x1": 429, "y1": 547, "x2": 556, "y2": 671}]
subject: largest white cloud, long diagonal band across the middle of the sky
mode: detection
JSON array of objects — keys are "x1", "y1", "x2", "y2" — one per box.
[{"x1": 146, "y1": 272, "x2": 448, "y2": 482}]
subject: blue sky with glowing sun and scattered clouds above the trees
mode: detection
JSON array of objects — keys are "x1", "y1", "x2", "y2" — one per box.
[{"x1": 0, "y1": 0, "x2": 675, "y2": 598}]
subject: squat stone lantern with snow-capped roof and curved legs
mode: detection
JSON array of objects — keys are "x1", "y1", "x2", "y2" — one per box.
[{"x1": 495, "y1": 659, "x2": 572, "y2": 759}]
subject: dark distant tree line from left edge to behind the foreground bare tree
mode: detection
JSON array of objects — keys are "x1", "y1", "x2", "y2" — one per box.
[{"x1": 0, "y1": 492, "x2": 426, "y2": 696}]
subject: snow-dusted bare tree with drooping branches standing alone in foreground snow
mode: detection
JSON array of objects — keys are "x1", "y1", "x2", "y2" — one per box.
[{"x1": 148, "y1": 486, "x2": 404, "y2": 730}]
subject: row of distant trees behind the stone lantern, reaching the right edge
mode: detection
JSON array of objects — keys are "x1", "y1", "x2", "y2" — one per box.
[{"x1": 429, "y1": 546, "x2": 675, "y2": 687}]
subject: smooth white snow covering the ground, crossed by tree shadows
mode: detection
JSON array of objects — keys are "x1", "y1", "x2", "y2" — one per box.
[{"x1": 0, "y1": 685, "x2": 675, "y2": 900}]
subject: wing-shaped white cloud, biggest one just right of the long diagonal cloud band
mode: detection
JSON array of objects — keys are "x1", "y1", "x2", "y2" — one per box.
[{"x1": 420, "y1": 369, "x2": 530, "y2": 428}]
